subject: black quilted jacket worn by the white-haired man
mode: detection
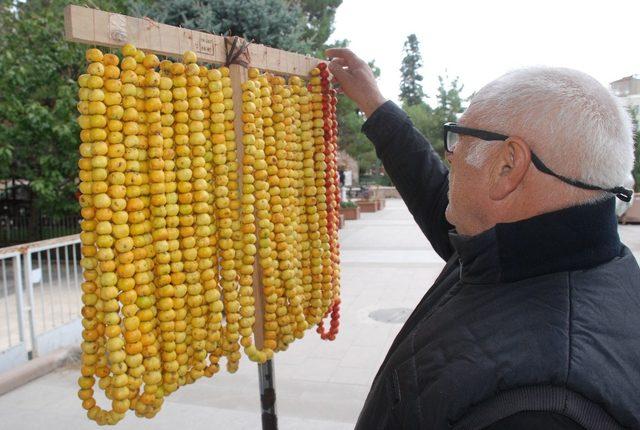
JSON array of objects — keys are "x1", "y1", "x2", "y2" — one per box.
[{"x1": 356, "y1": 102, "x2": 640, "y2": 430}]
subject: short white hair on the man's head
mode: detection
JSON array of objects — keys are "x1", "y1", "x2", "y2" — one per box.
[{"x1": 461, "y1": 67, "x2": 634, "y2": 192}]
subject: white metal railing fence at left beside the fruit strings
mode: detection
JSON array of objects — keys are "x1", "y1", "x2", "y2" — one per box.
[{"x1": 0, "y1": 235, "x2": 82, "y2": 372}]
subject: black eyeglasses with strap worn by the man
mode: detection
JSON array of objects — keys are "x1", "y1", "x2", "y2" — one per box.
[{"x1": 444, "y1": 122, "x2": 633, "y2": 202}]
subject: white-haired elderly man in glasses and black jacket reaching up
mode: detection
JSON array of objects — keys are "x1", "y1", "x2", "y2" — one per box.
[{"x1": 327, "y1": 49, "x2": 640, "y2": 430}]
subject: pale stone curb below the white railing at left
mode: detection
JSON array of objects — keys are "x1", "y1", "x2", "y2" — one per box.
[{"x1": 0, "y1": 347, "x2": 78, "y2": 396}]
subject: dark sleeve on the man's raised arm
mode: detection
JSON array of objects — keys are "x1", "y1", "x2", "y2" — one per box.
[{"x1": 362, "y1": 101, "x2": 453, "y2": 260}]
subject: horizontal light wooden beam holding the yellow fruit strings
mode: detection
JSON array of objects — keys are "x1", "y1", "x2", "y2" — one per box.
[{"x1": 64, "y1": 5, "x2": 324, "y2": 76}]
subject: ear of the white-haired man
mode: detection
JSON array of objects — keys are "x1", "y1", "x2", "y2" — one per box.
[{"x1": 489, "y1": 137, "x2": 531, "y2": 200}]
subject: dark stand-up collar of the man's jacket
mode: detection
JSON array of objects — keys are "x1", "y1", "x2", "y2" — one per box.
[{"x1": 449, "y1": 198, "x2": 622, "y2": 284}]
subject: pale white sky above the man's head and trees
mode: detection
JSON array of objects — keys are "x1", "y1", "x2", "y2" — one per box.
[{"x1": 331, "y1": 0, "x2": 640, "y2": 103}]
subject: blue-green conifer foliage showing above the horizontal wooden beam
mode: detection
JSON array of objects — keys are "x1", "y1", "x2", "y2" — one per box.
[{"x1": 131, "y1": 0, "x2": 316, "y2": 53}]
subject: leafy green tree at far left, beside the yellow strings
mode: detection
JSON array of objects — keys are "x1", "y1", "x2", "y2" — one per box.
[{"x1": 0, "y1": 0, "x2": 131, "y2": 215}]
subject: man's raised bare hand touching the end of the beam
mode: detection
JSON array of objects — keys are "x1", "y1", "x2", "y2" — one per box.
[{"x1": 325, "y1": 48, "x2": 387, "y2": 117}]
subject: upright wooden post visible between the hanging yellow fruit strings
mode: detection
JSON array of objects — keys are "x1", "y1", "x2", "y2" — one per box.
[{"x1": 229, "y1": 64, "x2": 264, "y2": 349}]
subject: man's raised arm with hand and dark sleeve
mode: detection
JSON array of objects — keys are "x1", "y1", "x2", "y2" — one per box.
[{"x1": 327, "y1": 49, "x2": 453, "y2": 260}]
